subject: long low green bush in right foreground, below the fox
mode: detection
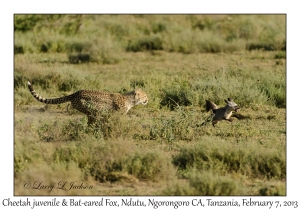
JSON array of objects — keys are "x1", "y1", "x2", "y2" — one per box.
[{"x1": 173, "y1": 142, "x2": 286, "y2": 179}]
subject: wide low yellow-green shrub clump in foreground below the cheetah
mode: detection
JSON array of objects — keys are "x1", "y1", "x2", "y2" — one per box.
[{"x1": 53, "y1": 141, "x2": 175, "y2": 182}]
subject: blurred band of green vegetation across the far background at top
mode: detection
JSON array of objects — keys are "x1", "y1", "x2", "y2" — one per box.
[{"x1": 14, "y1": 15, "x2": 286, "y2": 56}]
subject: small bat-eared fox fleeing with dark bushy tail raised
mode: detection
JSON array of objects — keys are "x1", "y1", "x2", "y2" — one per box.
[{"x1": 206, "y1": 98, "x2": 240, "y2": 126}]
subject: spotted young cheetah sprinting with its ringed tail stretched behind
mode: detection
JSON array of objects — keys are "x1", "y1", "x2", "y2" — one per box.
[{"x1": 28, "y1": 81, "x2": 148, "y2": 124}]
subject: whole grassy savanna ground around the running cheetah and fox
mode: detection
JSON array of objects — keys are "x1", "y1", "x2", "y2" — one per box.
[{"x1": 14, "y1": 15, "x2": 286, "y2": 195}]
